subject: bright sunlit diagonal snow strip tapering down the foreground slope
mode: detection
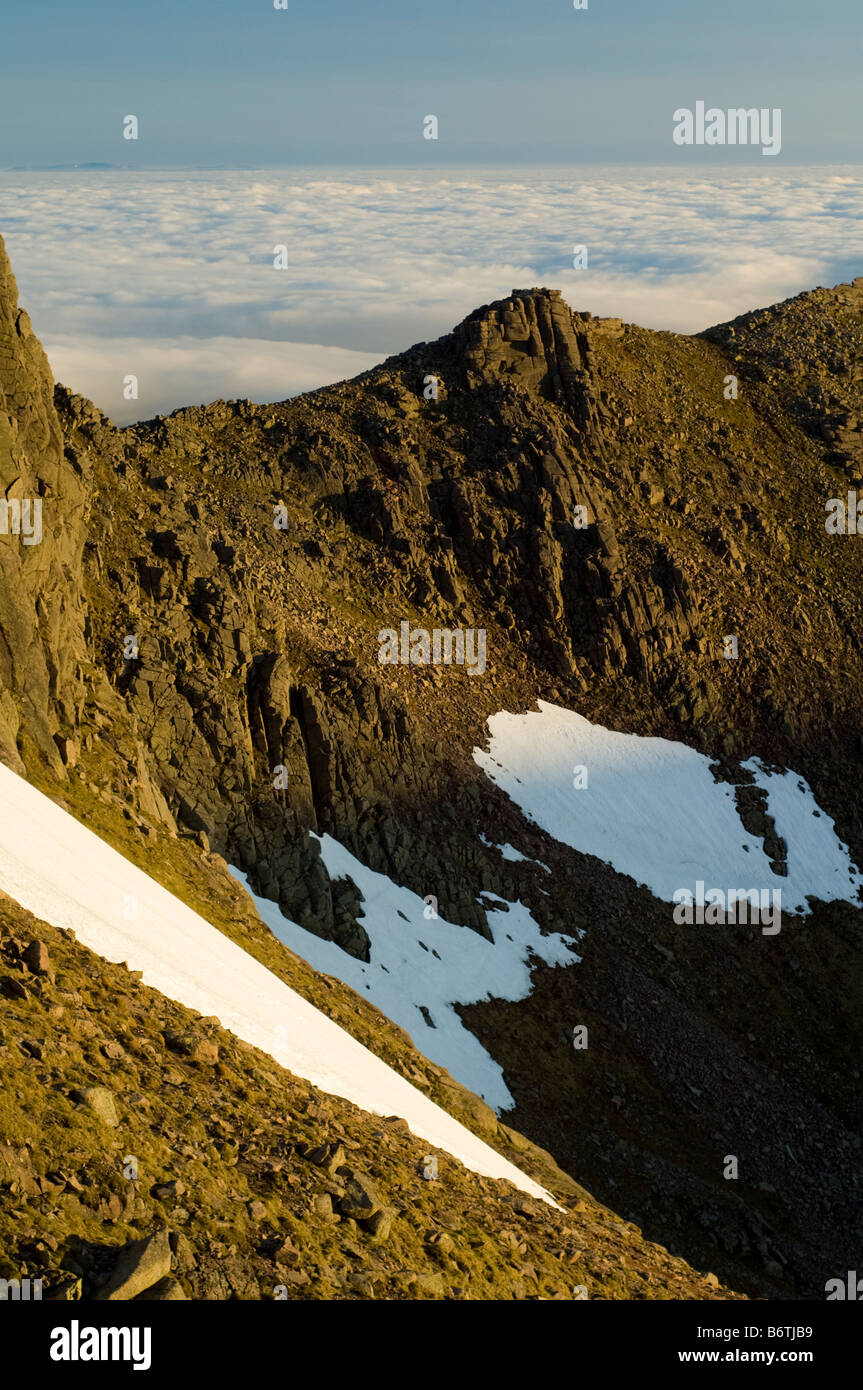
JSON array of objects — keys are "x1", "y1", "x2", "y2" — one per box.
[{"x1": 0, "y1": 765, "x2": 554, "y2": 1205}]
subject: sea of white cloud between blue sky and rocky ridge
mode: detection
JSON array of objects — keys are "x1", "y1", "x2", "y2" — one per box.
[{"x1": 0, "y1": 165, "x2": 863, "y2": 423}]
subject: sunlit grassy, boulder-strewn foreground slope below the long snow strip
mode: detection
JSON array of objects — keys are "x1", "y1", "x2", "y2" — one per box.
[{"x1": 0, "y1": 899, "x2": 735, "y2": 1300}]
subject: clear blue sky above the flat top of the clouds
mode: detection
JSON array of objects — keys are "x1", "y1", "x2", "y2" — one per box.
[{"x1": 0, "y1": 0, "x2": 863, "y2": 168}]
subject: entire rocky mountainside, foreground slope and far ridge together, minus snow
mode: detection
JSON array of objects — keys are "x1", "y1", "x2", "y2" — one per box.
[{"x1": 0, "y1": 227, "x2": 863, "y2": 1298}]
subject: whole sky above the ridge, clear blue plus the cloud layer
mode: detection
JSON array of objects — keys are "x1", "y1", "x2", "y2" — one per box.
[{"x1": 0, "y1": 0, "x2": 863, "y2": 424}]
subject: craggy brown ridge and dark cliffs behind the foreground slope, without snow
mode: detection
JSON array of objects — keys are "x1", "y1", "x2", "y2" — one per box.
[{"x1": 0, "y1": 230, "x2": 863, "y2": 1297}]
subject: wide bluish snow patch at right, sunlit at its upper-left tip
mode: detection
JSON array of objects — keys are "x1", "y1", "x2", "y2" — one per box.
[{"x1": 474, "y1": 701, "x2": 863, "y2": 915}]
